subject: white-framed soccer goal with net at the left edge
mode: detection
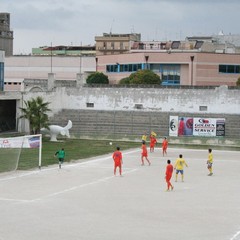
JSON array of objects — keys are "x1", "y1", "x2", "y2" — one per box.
[{"x1": 0, "y1": 134, "x2": 42, "y2": 173}]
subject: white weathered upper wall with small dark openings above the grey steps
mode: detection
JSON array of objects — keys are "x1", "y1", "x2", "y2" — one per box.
[{"x1": 20, "y1": 86, "x2": 240, "y2": 117}]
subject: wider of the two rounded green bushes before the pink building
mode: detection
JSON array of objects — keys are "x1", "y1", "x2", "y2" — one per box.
[{"x1": 119, "y1": 69, "x2": 162, "y2": 84}]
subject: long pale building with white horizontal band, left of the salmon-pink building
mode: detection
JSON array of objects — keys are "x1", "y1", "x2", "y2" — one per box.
[{"x1": 4, "y1": 55, "x2": 96, "y2": 91}]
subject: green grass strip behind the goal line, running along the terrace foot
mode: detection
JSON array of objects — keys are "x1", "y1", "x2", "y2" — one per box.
[{"x1": 0, "y1": 138, "x2": 240, "y2": 172}]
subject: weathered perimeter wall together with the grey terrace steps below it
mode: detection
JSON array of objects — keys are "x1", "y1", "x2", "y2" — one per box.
[{"x1": 14, "y1": 83, "x2": 240, "y2": 144}]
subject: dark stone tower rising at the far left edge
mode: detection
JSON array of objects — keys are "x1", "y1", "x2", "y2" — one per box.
[{"x1": 0, "y1": 13, "x2": 13, "y2": 56}]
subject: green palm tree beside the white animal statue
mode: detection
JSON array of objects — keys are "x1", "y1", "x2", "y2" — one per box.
[{"x1": 20, "y1": 97, "x2": 51, "y2": 134}]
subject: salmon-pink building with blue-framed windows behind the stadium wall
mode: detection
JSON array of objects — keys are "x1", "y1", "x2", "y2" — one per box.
[{"x1": 96, "y1": 49, "x2": 240, "y2": 86}]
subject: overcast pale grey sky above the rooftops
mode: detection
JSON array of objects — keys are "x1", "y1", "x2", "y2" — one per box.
[{"x1": 0, "y1": 0, "x2": 240, "y2": 54}]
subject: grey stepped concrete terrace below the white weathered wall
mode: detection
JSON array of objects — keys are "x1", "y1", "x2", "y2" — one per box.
[{"x1": 50, "y1": 109, "x2": 240, "y2": 139}]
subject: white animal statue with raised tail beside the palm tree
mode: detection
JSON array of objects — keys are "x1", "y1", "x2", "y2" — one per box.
[{"x1": 41, "y1": 120, "x2": 72, "y2": 142}]
